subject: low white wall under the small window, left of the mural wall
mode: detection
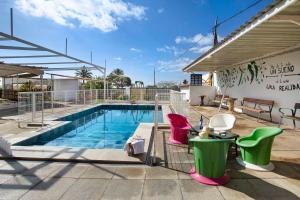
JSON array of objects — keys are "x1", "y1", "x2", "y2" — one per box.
[{"x1": 189, "y1": 86, "x2": 216, "y2": 105}]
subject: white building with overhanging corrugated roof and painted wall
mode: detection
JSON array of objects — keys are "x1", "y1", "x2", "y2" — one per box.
[{"x1": 183, "y1": 0, "x2": 300, "y2": 123}]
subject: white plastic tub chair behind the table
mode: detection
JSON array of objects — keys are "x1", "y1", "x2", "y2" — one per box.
[{"x1": 208, "y1": 113, "x2": 236, "y2": 132}]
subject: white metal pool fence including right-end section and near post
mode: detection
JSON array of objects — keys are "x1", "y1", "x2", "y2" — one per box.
[{"x1": 18, "y1": 88, "x2": 189, "y2": 166}]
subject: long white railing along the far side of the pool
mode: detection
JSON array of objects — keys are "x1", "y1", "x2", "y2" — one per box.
[{"x1": 18, "y1": 88, "x2": 170, "y2": 126}]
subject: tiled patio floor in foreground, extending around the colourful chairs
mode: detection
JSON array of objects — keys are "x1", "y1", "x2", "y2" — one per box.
[{"x1": 0, "y1": 107, "x2": 300, "y2": 200}]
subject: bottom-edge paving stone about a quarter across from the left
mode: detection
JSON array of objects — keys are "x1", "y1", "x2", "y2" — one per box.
[{"x1": 60, "y1": 179, "x2": 108, "y2": 200}]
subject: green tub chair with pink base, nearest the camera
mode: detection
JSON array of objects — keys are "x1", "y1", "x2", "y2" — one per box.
[{"x1": 189, "y1": 136, "x2": 234, "y2": 185}]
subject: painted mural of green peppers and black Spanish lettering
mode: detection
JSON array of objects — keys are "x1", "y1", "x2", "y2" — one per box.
[{"x1": 217, "y1": 60, "x2": 300, "y2": 91}]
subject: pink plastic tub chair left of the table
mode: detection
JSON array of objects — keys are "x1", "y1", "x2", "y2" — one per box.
[{"x1": 168, "y1": 114, "x2": 192, "y2": 144}]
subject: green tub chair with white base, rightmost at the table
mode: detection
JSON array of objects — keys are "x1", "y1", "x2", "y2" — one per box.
[{"x1": 236, "y1": 127, "x2": 282, "y2": 170}]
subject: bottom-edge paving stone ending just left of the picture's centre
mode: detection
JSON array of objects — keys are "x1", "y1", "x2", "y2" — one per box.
[{"x1": 101, "y1": 179, "x2": 144, "y2": 200}]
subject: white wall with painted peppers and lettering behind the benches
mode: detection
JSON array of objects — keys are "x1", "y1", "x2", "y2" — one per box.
[{"x1": 214, "y1": 51, "x2": 300, "y2": 126}]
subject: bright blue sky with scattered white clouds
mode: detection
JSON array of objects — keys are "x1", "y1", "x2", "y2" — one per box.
[{"x1": 0, "y1": 0, "x2": 272, "y2": 85}]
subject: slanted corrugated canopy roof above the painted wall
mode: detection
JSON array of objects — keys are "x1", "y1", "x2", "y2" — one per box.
[{"x1": 183, "y1": 0, "x2": 300, "y2": 72}]
